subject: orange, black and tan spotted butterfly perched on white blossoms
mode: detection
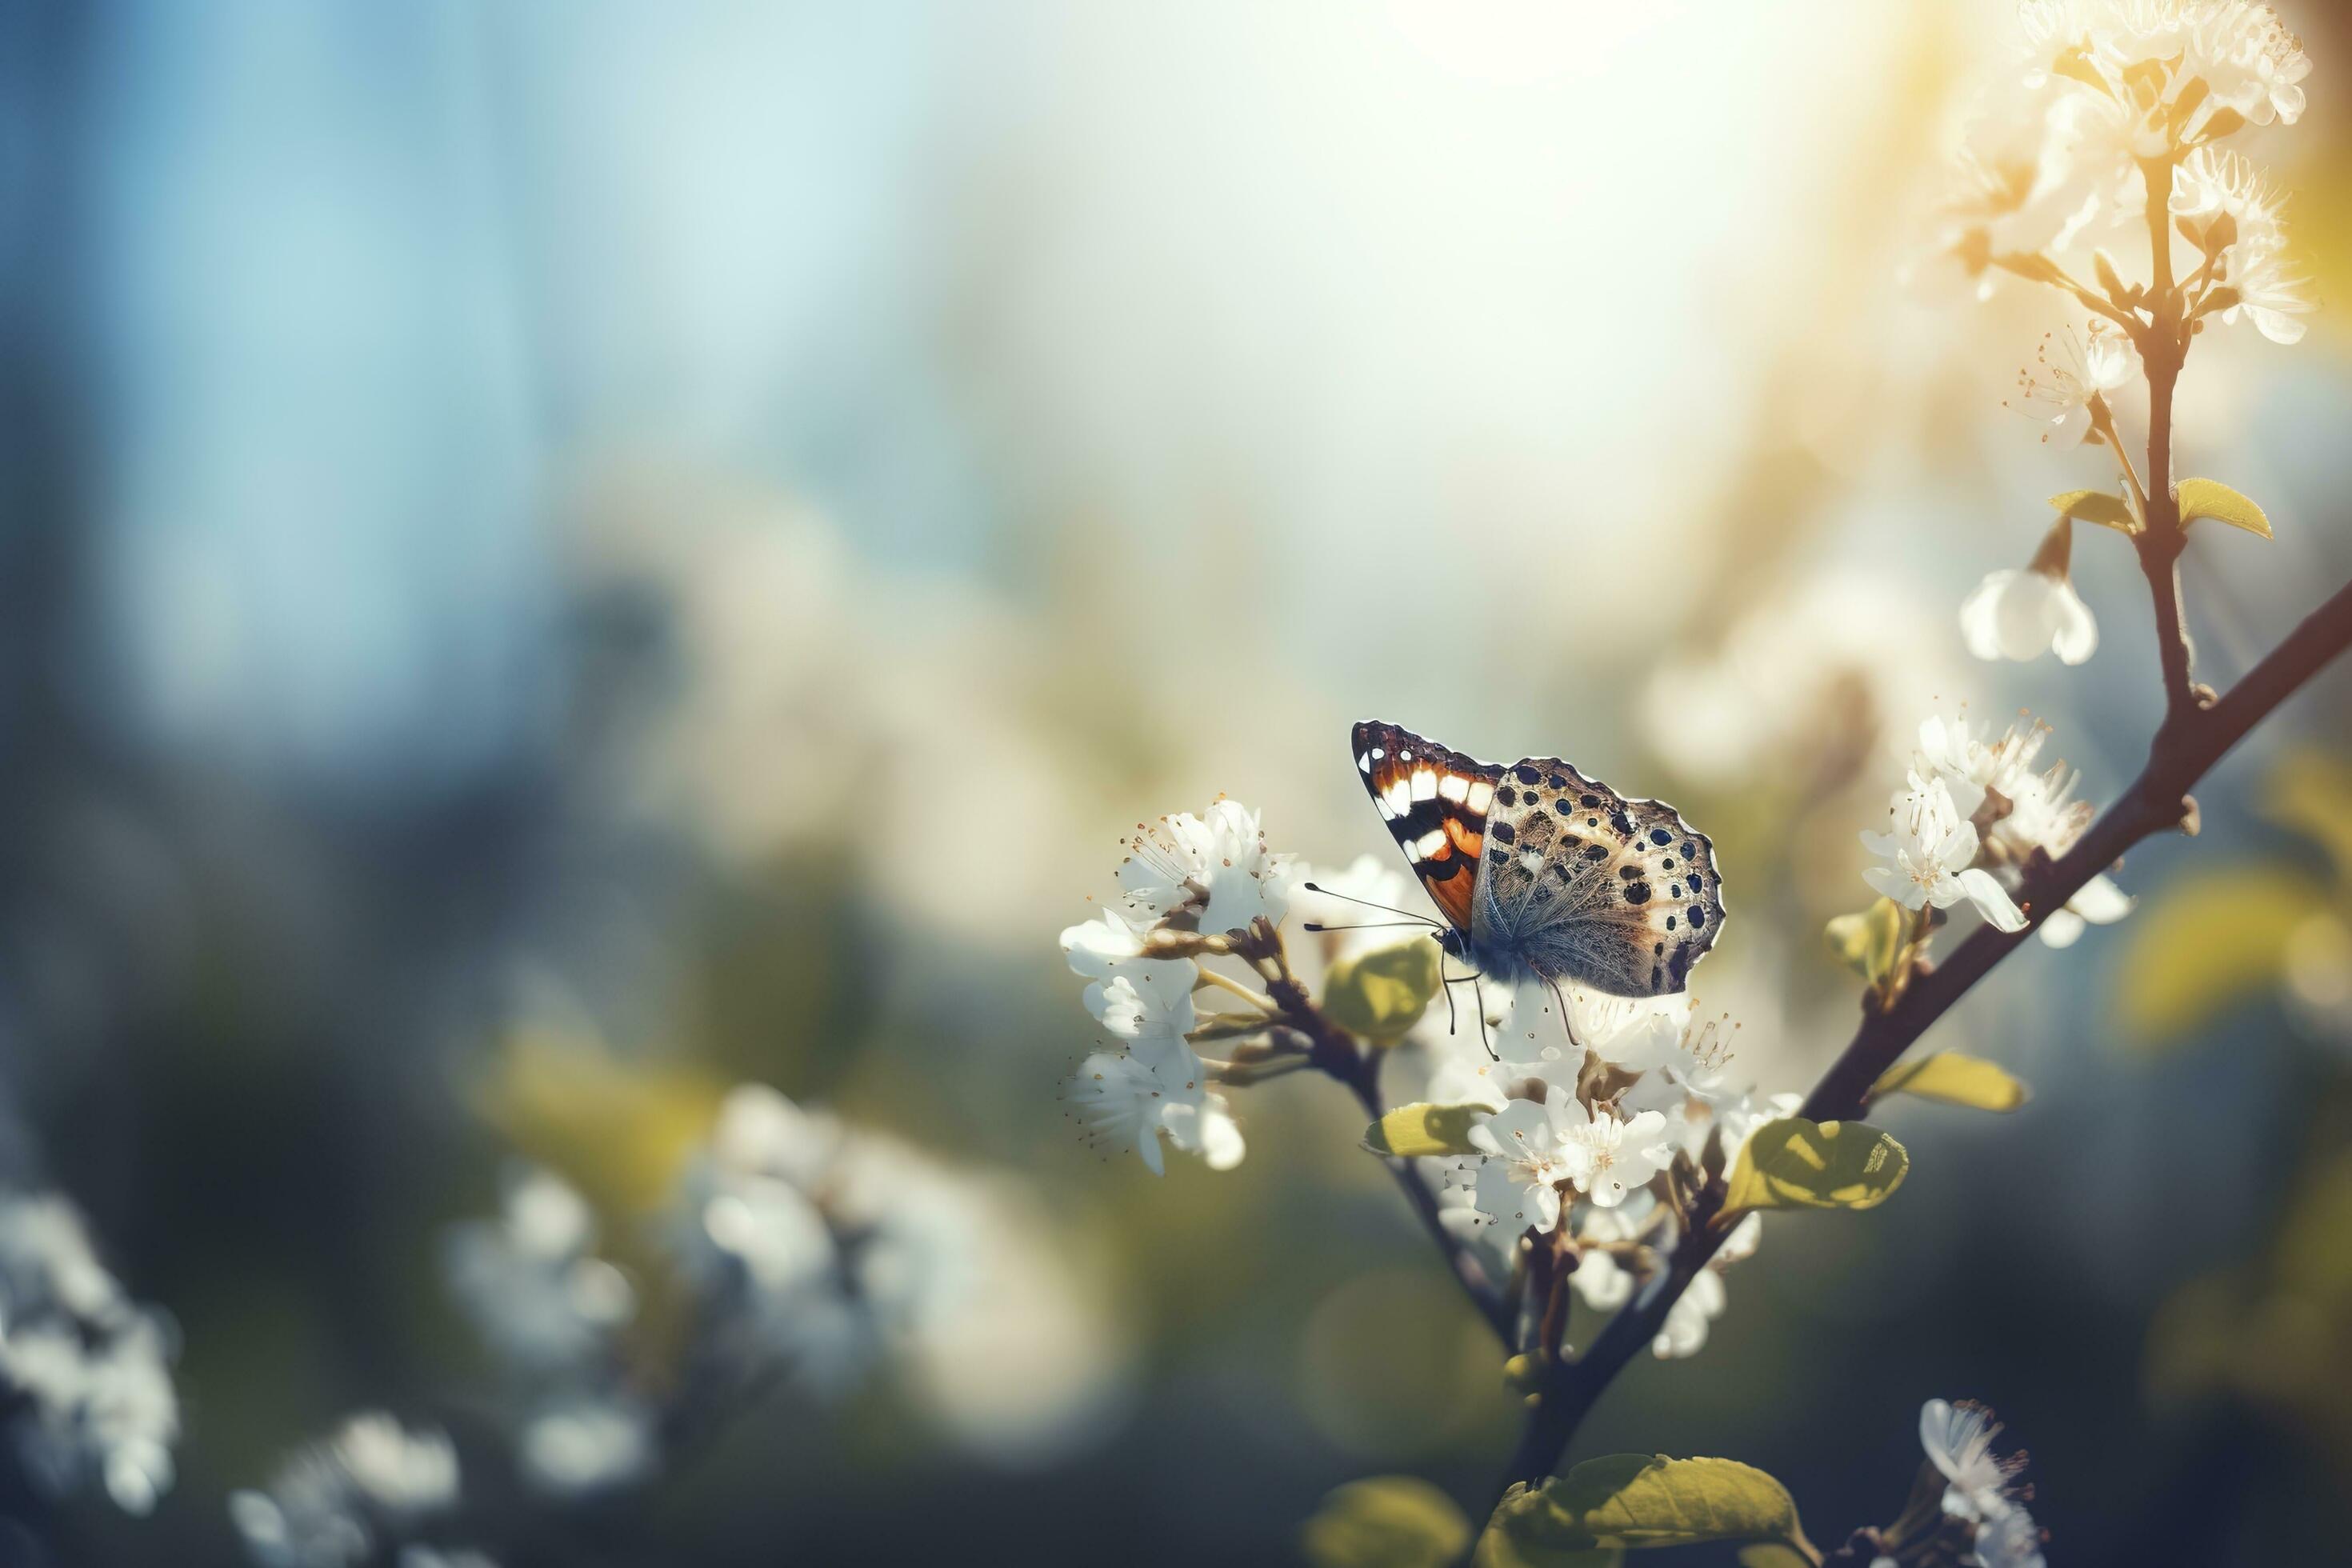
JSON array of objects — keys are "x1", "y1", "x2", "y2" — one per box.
[{"x1": 1353, "y1": 722, "x2": 1724, "y2": 1015}]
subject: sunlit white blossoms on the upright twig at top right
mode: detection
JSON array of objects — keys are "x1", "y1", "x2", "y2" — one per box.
[{"x1": 1936, "y1": 0, "x2": 2312, "y2": 663}]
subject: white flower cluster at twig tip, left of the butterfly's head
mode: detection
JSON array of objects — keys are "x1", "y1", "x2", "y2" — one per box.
[{"x1": 1061, "y1": 799, "x2": 1296, "y2": 1173}]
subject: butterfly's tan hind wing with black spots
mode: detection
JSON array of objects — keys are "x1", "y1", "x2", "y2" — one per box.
[{"x1": 1470, "y1": 757, "x2": 1724, "y2": 997}]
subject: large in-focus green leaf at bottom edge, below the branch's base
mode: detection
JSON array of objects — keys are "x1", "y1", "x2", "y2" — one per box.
[{"x1": 1486, "y1": 1453, "x2": 1821, "y2": 1566}]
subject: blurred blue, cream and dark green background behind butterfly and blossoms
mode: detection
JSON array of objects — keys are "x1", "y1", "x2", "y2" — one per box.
[{"x1": 0, "y1": 0, "x2": 2352, "y2": 1566}]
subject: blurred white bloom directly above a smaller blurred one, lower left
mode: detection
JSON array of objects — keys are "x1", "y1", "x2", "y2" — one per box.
[{"x1": 442, "y1": 1168, "x2": 638, "y2": 1370}]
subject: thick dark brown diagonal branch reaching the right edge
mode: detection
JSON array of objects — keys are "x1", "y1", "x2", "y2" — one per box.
[{"x1": 1506, "y1": 571, "x2": 2352, "y2": 1486}]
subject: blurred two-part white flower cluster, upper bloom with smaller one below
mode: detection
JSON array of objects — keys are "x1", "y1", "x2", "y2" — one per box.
[{"x1": 442, "y1": 1168, "x2": 654, "y2": 1498}]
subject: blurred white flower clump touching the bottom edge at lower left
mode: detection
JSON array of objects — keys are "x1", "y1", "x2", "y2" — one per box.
[{"x1": 228, "y1": 1410, "x2": 458, "y2": 1568}]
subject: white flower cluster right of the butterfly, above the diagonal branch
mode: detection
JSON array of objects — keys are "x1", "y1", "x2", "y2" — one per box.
[{"x1": 1862, "y1": 714, "x2": 2131, "y2": 947}]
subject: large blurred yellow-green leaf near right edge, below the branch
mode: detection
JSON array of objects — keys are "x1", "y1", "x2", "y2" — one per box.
[{"x1": 2114, "y1": 865, "x2": 2331, "y2": 1044}]
